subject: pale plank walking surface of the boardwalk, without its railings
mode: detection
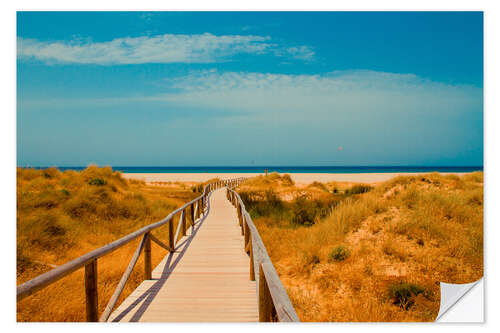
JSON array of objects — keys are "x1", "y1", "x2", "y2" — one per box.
[{"x1": 108, "y1": 188, "x2": 259, "y2": 322}]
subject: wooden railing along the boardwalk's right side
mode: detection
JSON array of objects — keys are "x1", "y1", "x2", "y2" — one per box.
[{"x1": 227, "y1": 180, "x2": 300, "y2": 322}]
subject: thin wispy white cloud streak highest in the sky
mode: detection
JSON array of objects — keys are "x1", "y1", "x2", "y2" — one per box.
[{"x1": 17, "y1": 33, "x2": 314, "y2": 65}]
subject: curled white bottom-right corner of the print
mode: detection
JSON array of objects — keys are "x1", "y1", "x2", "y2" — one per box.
[{"x1": 436, "y1": 278, "x2": 484, "y2": 322}]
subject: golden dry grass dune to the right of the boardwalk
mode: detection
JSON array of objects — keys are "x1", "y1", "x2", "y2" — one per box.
[{"x1": 238, "y1": 172, "x2": 483, "y2": 321}]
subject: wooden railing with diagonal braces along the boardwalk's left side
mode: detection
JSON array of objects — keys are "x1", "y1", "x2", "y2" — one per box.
[{"x1": 17, "y1": 178, "x2": 242, "y2": 321}]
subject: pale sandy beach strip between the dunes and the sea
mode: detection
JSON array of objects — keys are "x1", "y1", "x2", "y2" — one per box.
[{"x1": 123, "y1": 173, "x2": 463, "y2": 184}]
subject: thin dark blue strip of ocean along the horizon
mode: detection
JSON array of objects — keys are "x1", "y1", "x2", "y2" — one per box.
[{"x1": 32, "y1": 166, "x2": 483, "y2": 173}]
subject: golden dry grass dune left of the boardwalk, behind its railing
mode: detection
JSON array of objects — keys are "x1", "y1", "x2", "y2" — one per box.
[{"x1": 17, "y1": 167, "x2": 202, "y2": 321}]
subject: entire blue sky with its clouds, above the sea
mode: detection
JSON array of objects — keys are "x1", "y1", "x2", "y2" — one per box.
[{"x1": 17, "y1": 12, "x2": 483, "y2": 166}]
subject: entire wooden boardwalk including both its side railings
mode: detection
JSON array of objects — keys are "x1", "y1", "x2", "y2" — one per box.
[{"x1": 16, "y1": 178, "x2": 300, "y2": 322}]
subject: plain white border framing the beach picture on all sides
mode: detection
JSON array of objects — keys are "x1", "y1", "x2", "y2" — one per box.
[{"x1": 0, "y1": 0, "x2": 500, "y2": 333}]
